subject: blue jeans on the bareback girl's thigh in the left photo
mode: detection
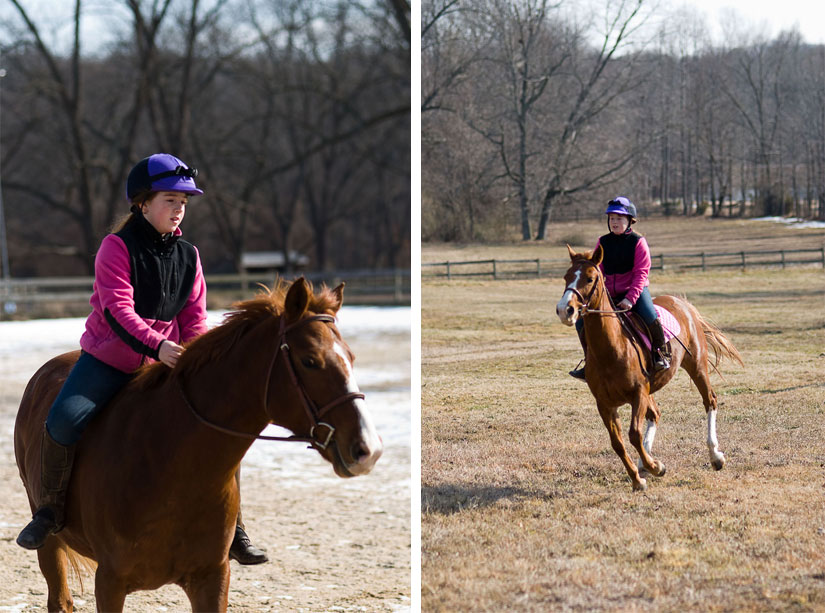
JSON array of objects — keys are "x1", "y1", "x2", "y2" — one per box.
[{"x1": 46, "y1": 351, "x2": 134, "y2": 445}]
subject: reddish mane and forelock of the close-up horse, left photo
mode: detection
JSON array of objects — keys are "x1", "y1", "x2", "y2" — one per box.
[{"x1": 134, "y1": 279, "x2": 338, "y2": 391}]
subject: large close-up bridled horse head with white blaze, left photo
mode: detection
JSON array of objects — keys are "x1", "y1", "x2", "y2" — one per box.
[{"x1": 266, "y1": 278, "x2": 383, "y2": 477}]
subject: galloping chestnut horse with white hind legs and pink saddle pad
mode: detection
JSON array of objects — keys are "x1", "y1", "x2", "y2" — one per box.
[{"x1": 556, "y1": 245, "x2": 742, "y2": 490}]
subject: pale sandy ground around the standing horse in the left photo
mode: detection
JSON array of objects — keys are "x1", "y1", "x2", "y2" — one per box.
[{"x1": 0, "y1": 322, "x2": 411, "y2": 612}]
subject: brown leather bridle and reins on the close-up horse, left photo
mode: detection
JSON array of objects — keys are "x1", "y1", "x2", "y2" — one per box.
[{"x1": 178, "y1": 314, "x2": 364, "y2": 450}]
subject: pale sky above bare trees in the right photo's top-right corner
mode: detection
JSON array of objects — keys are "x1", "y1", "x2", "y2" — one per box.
[{"x1": 672, "y1": 0, "x2": 825, "y2": 44}]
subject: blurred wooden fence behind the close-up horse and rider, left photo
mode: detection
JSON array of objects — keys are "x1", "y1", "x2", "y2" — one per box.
[{"x1": 0, "y1": 269, "x2": 411, "y2": 319}]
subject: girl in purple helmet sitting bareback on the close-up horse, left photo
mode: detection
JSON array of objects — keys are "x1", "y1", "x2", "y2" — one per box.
[{"x1": 17, "y1": 153, "x2": 267, "y2": 564}]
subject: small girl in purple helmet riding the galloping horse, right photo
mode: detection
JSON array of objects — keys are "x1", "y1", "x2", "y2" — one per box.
[{"x1": 570, "y1": 196, "x2": 670, "y2": 379}]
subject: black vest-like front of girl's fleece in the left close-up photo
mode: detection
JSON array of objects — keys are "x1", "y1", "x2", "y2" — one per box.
[{"x1": 115, "y1": 215, "x2": 197, "y2": 321}]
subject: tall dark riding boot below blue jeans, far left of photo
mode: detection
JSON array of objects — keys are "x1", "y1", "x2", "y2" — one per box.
[{"x1": 17, "y1": 426, "x2": 75, "y2": 549}]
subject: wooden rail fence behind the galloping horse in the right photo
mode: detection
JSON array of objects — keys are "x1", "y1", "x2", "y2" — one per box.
[{"x1": 421, "y1": 247, "x2": 825, "y2": 279}]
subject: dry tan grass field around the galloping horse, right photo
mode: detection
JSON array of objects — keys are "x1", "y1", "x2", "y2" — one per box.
[{"x1": 421, "y1": 219, "x2": 825, "y2": 612}]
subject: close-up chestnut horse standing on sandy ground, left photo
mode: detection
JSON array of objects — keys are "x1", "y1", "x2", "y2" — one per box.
[{"x1": 14, "y1": 279, "x2": 382, "y2": 611}]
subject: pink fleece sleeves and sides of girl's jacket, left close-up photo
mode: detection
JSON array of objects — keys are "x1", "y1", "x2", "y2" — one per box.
[{"x1": 80, "y1": 229, "x2": 207, "y2": 372}]
